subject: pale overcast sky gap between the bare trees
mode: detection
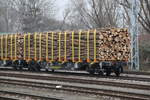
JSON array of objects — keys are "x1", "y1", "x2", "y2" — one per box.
[{"x1": 56, "y1": 0, "x2": 69, "y2": 20}]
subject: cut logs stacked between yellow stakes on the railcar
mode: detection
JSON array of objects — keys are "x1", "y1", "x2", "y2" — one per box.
[{"x1": 0, "y1": 28, "x2": 130, "y2": 61}]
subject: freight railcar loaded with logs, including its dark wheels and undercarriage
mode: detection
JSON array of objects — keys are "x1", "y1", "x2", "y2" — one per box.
[{"x1": 0, "y1": 28, "x2": 130, "y2": 76}]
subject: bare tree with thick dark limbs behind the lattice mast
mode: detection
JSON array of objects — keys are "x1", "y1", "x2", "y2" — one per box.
[{"x1": 118, "y1": 0, "x2": 150, "y2": 33}]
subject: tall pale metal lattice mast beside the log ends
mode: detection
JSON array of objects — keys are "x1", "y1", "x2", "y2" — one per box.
[{"x1": 130, "y1": 0, "x2": 139, "y2": 71}]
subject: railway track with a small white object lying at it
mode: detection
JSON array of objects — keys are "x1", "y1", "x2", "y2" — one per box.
[{"x1": 1, "y1": 76, "x2": 150, "y2": 100}]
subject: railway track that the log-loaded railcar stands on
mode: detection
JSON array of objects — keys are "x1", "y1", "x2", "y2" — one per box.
[{"x1": 0, "y1": 69, "x2": 150, "y2": 82}]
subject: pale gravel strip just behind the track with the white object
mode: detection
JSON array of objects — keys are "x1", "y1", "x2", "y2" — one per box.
[{"x1": 0, "y1": 76, "x2": 150, "y2": 96}]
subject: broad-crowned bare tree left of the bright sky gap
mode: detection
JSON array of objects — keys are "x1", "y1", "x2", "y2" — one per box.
[{"x1": 8, "y1": 0, "x2": 54, "y2": 32}]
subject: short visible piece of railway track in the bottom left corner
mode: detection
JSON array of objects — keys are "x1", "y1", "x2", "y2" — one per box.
[{"x1": 0, "y1": 90, "x2": 62, "y2": 100}]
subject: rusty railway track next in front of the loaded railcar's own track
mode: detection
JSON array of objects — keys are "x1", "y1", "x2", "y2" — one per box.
[{"x1": 0, "y1": 73, "x2": 150, "y2": 90}]
